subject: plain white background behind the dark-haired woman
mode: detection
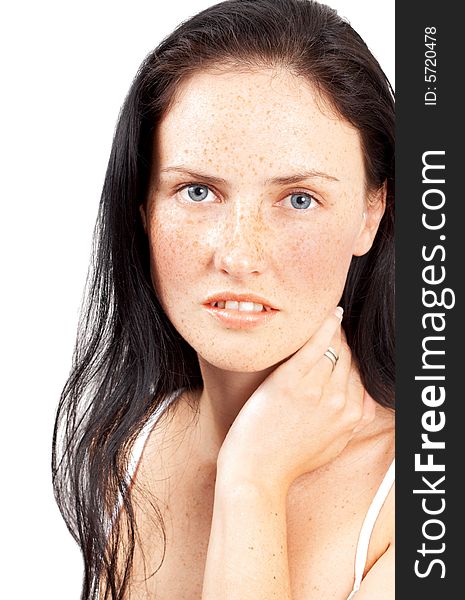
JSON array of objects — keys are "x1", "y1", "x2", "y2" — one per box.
[{"x1": 0, "y1": 0, "x2": 394, "y2": 600}]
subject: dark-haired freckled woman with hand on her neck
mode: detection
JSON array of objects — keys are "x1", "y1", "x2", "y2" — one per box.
[{"x1": 53, "y1": 0, "x2": 394, "y2": 600}]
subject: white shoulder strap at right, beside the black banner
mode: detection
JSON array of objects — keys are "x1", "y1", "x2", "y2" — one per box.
[{"x1": 347, "y1": 460, "x2": 395, "y2": 600}]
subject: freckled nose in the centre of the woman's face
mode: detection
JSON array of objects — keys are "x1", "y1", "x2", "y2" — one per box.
[{"x1": 214, "y1": 202, "x2": 267, "y2": 279}]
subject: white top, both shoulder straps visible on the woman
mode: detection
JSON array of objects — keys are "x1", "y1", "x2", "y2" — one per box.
[{"x1": 118, "y1": 392, "x2": 395, "y2": 600}]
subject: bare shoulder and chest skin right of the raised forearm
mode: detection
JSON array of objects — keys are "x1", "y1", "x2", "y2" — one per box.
[{"x1": 288, "y1": 408, "x2": 395, "y2": 600}]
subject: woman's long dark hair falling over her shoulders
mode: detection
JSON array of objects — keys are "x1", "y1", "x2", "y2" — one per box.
[{"x1": 52, "y1": 0, "x2": 394, "y2": 600}]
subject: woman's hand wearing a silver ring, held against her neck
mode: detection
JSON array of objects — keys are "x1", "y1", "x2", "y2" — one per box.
[{"x1": 217, "y1": 308, "x2": 375, "y2": 492}]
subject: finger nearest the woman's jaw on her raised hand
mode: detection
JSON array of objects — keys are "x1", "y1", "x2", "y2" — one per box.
[{"x1": 284, "y1": 307, "x2": 342, "y2": 375}]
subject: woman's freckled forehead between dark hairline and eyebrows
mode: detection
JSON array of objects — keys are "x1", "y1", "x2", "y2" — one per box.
[{"x1": 156, "y1": 69, "x2": 363, "y2": 180}]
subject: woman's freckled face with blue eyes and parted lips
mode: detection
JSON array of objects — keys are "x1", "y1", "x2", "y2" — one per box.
[{"x1": 141, "y1": 70, "x2": 384, "y2": 372}]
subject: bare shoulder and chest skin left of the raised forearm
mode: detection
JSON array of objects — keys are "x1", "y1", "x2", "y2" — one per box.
[{"x1": 114, "y1": 396, "x2": 215, "y2": 600}]
